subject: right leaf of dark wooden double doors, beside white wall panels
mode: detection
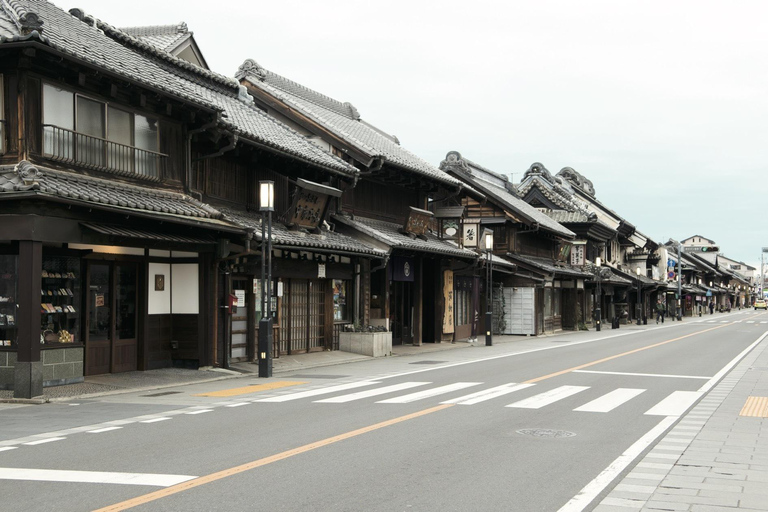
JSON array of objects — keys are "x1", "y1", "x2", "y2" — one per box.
[{"x1": 112, "y1": 263, "x2": 138, "y2": 373}]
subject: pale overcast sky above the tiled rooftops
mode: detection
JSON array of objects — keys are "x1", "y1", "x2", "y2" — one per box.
[{"x1": 67, "y1": 0, "x2": 768, "y2": 266}]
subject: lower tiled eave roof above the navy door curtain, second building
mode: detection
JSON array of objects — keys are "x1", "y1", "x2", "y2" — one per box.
[{"x1": 333, "y1": 215, "x2": 478, "y2": 259}]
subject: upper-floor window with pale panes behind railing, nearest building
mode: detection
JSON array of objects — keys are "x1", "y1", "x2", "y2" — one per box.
[{"x1": 43, "y1": 84, "x2": 167, "y2": 178}]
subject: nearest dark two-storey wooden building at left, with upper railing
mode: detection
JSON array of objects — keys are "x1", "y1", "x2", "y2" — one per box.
[{"x1": 0, "y1": 0, "x2": 383, "y2": 397}]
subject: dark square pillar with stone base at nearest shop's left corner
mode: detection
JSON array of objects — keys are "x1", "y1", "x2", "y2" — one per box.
[{"x1": 13, "y1": 240, "x2": 43, "y2": 398}]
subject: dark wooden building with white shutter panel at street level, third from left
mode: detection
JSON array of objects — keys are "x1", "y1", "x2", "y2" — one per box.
[{"x1": 440, "y1": 151, "x2": 590, "y2": 335}]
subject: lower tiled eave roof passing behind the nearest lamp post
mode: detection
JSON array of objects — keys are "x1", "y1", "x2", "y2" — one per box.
[{"x1": 222, "y1": 208, "x2": 386, "y2": 257}]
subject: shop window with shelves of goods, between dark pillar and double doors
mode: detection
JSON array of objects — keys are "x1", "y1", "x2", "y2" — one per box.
[{"x1": 40, "y1": 256, "x2": 82, "y2": 344}]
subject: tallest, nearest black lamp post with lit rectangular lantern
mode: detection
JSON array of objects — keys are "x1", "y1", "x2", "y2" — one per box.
[{"x1": 259, "y1": 181, "x2": 275, "y2": 377}]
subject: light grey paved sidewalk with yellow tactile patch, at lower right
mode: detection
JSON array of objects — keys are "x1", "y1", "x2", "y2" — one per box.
[{"x1": 594, "y1": 330, "x2": 768, "y2": 512}]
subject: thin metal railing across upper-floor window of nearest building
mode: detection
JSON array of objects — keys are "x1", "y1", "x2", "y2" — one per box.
[{"x1": 43, "y1": 124, "x2": 168, "y2": 179}]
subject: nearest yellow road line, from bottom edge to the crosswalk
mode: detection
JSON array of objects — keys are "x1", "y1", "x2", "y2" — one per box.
[{"x1": 94, "y1": 404, "x2": 454, "y2": 512}]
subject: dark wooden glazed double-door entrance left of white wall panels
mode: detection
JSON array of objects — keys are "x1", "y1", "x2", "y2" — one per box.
[{"x1": 85, "y1": 262, "x2": 138, "y2": 375}]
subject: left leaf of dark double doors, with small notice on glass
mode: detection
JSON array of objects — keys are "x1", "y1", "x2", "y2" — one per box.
[{"x1": 85, "y1": 263, "x2": 113, "y2": 375}]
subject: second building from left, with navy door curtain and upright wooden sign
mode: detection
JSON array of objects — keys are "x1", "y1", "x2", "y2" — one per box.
[{"x1": 237, "y1": 60, "x2": 480, "y2": 345}]
